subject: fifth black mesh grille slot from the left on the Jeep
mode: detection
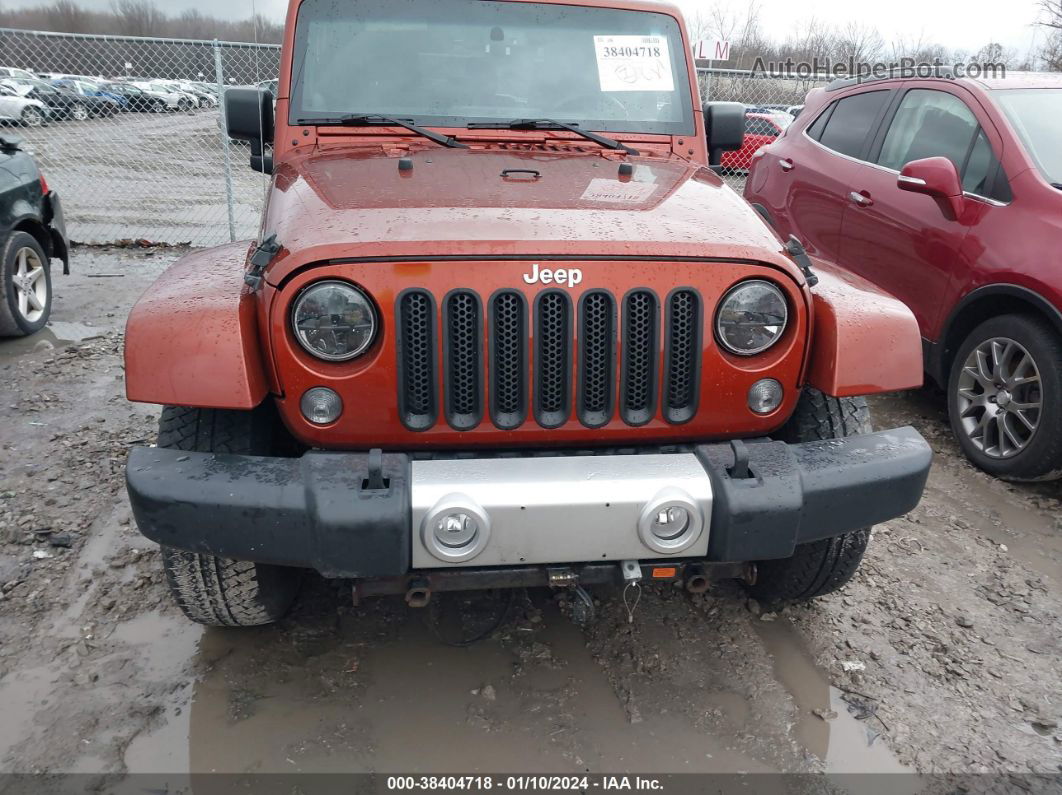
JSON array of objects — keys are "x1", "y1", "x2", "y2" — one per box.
[{"x1": 579, "y1": 290, "x2": 616, "y2": 428}]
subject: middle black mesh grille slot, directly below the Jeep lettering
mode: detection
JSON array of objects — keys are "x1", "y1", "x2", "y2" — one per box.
[{"x1": 534, "y1": 291, "x2": 571, "y2": 428}]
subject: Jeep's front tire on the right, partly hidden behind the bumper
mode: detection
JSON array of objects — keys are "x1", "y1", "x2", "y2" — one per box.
[{"x1": 749, "y1": 387, "x2": 871, "y2": 604}]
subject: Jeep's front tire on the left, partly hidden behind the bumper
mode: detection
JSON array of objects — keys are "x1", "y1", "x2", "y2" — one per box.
[{"x1": 149, "y1": 403, "x2": 302, "y2": 626}]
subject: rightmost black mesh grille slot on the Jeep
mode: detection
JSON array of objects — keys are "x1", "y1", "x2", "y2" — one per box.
[{"x1": 664, "y1": 290, "x2": 702, "y2": 424}]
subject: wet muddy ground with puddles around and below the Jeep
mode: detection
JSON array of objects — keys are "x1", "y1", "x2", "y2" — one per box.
[{"x1": 0, "y1": 248, "x2": 1062, "y2": 789}]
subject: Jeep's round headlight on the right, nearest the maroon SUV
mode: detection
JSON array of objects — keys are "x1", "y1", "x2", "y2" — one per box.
[{"x1": 716, "y1": 279, "x2": 789, "y2": 356}]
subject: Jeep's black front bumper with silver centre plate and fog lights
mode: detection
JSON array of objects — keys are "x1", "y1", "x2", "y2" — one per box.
[{"x1": 126, "y1": 428, "x2": 931, "y2": 578}]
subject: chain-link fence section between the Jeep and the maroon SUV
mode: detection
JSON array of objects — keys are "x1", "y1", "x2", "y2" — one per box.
[{"x1": 697, "y1": 68, "x2": 828, "y2": 184}]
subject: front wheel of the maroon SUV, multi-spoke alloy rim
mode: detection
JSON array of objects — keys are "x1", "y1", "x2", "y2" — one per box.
[{"x1": 947, "y1": 314, "x2": 1062, "y2": 481}]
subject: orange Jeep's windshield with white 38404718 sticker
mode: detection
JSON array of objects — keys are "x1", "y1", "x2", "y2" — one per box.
[{"x1": 290, "y1": 0, "x2": 693, "y2": 135}]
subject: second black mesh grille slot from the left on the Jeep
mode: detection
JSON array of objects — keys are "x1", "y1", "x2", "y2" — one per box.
[{"x1": 443, "y1": 290, "x2": 483, "y2": 431}]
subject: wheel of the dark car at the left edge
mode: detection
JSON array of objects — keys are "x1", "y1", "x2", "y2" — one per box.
[{"x1": 0, "y1": 231, "x2": 52, "y2": 336}]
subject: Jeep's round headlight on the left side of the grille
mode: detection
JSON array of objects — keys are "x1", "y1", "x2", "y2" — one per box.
[{"x1": 291, "y1": 281, "x2": 376, "y2": 362}]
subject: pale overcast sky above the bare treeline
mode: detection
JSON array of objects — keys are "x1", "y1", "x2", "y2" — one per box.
[{"x1": 0, "y1": 0, "x2": 1037, "y2": 55}]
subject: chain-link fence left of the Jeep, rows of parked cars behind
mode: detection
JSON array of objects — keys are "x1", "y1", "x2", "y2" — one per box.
[{"x1": 0, "y1": 29, "x2": 280, "y2": 245}]
